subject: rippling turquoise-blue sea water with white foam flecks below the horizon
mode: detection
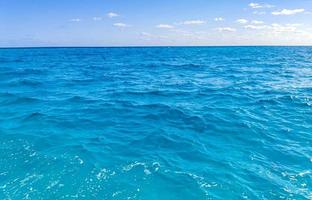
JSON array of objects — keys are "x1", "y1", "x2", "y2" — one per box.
[{"x1": 0, "y1": 47, "x2": 312, "y2": 200}]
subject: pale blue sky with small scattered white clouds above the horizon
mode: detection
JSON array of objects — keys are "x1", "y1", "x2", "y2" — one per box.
[{"x1": 0, "y1": 0, "x2": 312, "y2": 47}]
